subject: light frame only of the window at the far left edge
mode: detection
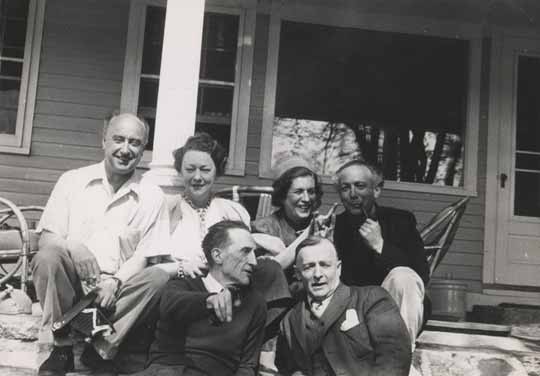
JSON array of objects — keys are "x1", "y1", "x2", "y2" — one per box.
[{"x1": 0, "y1": 0, "x2": 46, "y2": 155}]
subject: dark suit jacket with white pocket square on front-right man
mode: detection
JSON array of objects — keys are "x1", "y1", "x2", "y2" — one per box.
[{"x1": 276, "y1": 284, "x2": 411, "y2": 376}]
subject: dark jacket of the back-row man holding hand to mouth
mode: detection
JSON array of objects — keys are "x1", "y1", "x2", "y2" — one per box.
[{"x1": 334, "y1": 206, "x2": 429, "y2": 286}]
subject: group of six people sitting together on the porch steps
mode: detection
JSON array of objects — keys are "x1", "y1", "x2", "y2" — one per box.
[{"x1": 32, "y1": 113, "x2": 429, "y2": 376}]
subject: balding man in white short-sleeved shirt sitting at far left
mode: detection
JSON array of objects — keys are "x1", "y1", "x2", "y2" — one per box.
[{"x1": 32, "y1": 113, "x2": 170, "y2": 376}]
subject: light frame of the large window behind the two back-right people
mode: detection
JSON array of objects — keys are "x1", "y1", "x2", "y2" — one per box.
[{"x1": 259, "y1": 1, "x2": 482, "y2": 196}]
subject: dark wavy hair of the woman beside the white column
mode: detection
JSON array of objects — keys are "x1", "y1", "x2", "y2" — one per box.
[{"x1": 173, "y1": 132, "x2": 227, "y2": 176}]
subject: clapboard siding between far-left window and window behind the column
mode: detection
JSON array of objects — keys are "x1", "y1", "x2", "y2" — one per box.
[{"x1": 0, "y1": 0, "x2": 129, "y2": 205}]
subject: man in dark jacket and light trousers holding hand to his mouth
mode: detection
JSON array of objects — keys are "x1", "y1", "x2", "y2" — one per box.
[{"x1": 334, "y1": 160, "x2": 429, "y2": 349}]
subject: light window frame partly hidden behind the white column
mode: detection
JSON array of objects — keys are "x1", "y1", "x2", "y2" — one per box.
[{"x1": 120, "y1": 0, "x2": 256, "y2": 176}]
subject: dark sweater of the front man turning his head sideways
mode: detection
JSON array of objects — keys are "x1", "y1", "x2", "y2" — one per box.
[{"x1": 150, "y1": 278, "x2": 266, "y2": 376}]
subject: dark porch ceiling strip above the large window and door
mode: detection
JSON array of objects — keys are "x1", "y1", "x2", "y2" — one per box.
[{"x1": 294, "y1": 0, "x2": 540, "y2": 29}]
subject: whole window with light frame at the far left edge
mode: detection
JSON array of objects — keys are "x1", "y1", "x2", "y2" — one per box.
[{"x1": 0, "y1": 0, "x2": 45, "y2": 153}]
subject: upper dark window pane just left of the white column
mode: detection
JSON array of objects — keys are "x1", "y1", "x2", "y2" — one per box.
[{"x1": 141, "y1": 7, "x2": 165, "y2": 75}]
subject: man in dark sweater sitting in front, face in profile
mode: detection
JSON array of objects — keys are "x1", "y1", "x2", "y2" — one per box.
[{"x1": 141, "y1": 221, "x2": 266, "y2": 376}]
